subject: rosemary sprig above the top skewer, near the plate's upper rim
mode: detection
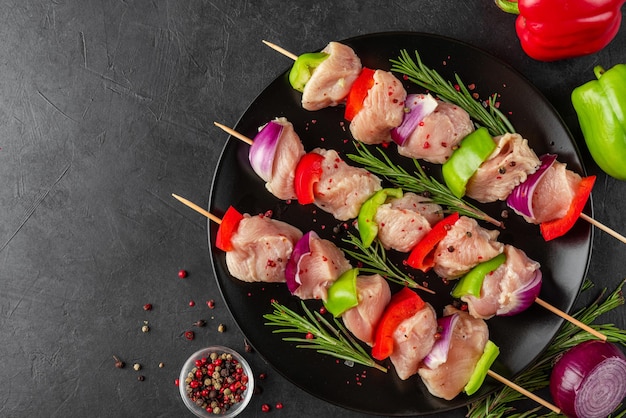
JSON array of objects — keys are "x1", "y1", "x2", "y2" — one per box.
[{"x1": 390, "y1": 50, "x2": 515, "y2": 136}]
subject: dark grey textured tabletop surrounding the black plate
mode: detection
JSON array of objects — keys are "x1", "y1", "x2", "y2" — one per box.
[{"x1": 0, "y1": 0, "x2": 626, "y2": 417}]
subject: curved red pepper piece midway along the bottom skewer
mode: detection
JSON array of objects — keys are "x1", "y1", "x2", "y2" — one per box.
[{"x1": 372, "y1": 287, "x2": 425, "y2": 360}]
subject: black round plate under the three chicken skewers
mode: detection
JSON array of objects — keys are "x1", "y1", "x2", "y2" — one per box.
[{"x1": 208, "y1": 32, "x2": 592, "y2": 416}]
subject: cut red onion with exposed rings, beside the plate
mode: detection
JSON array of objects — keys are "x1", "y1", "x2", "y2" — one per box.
[{"x1": 550, "y1": 340, "x2": 626, "y2": 418}]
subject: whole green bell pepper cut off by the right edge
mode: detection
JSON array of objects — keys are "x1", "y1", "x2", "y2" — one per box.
[{"x1": 571, "y1": 64, "x2": 626, "y2": 180}]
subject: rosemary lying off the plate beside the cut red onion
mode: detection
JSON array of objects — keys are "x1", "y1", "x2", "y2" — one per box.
[{"x1": 467, "y1": 280, "x2": 626, "y2": 418}]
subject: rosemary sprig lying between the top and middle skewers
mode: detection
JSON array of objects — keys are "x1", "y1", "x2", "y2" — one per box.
[{"x1": 348, "y1": 144, "x2": 502, "y2": 227}]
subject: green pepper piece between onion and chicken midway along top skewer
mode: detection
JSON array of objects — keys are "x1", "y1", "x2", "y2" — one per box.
[{"x1": 441, "y1": 127, "x2": 496, "y2": 198}]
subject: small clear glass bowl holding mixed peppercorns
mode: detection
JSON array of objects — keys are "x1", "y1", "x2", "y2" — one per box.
[{"x1": 178, "y1": 345, "x2": 254, "y2": 418}]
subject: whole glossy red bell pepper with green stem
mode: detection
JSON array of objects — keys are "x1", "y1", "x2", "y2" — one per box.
[{"x1": 495, "y1": 0, "x2": 626, "y2": 61}]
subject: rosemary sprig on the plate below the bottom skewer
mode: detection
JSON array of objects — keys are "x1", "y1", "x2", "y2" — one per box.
[{"x1": 263, "y1": 301, "x2": 387, "y2": 373}]
